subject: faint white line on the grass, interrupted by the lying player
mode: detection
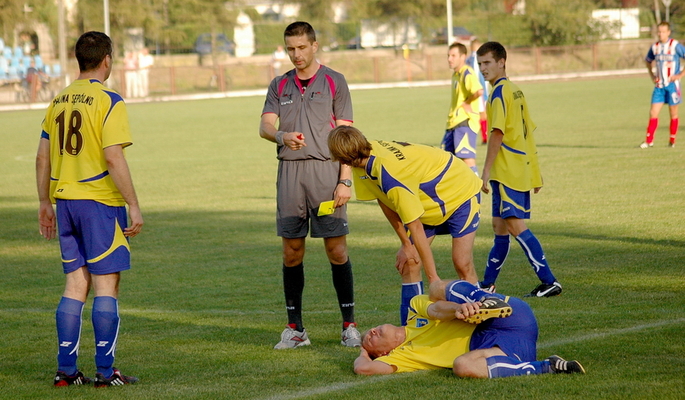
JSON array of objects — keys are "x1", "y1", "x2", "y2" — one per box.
[{"x1": 262, "y1": 318, "x2": 685, "y2": 400}]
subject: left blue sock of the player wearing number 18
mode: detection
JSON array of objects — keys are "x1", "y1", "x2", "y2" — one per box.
[{"x1": 55, "y1": 297, "x2": 83, "y2": 376}]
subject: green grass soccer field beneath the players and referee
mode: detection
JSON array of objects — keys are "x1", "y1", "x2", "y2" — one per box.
[{"x1": 0, "y1": 76, "x2": 685, "y2": 400}]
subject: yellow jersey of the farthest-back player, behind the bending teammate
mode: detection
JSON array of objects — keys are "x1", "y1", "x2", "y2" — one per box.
[{"x1": 447, "y1": 65, "x2": 485, "y2": 132}]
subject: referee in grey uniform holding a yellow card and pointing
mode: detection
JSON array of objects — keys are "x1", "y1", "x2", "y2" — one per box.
[{"x1": 259, "y1": 22, "x2": 361, "y2": 349}]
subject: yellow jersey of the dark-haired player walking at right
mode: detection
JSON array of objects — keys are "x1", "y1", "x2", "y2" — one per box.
[{"x1": 487, "y1": 78, "x2": 542, "y2": 192}]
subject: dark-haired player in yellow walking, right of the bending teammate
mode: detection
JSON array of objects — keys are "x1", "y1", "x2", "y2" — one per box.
[{"x1": 477, "y1": 42, "x2": 561, "y2": 297}]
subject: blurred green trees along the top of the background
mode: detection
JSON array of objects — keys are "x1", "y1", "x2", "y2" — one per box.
[{"x1": 0, "y1": 0, "x2": 684, "y2": 52}]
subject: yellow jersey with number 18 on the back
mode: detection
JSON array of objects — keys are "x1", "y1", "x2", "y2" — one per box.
[{"x1": 41, "y1": 79, "x2": 133, "y2": 206}]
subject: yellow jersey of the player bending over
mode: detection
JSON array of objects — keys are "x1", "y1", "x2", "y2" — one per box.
[{"x1": 352, "y1": 140, "x2": 482, "y2": 225}]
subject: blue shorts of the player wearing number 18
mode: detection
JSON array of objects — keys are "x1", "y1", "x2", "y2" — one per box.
[{"x1": 57, "y1": 199, "x2": 131, "y2": 275}]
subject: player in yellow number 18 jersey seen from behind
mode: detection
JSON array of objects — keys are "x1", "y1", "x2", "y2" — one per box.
[{"x1": 36, "y1": 32, "x2": 143, "y2": 387}]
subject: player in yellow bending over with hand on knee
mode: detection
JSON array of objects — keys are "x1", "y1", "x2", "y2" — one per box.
[{"x1": 328, "y1": 126, "x2": 481, "y2": 325}]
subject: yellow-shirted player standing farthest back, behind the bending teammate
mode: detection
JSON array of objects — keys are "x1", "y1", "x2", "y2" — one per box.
[{"x1": 442, "y1": 43, "x2": 483, "y2": 174}]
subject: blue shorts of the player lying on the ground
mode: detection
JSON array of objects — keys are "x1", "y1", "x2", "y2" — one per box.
[{"x1": 469, "y1": 293, "x2": 538, "y2": 361}]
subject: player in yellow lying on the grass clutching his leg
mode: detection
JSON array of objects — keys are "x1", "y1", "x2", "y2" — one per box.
[{"x1": 354, "y1": 280, "x2": 585, "y2": 378}]
